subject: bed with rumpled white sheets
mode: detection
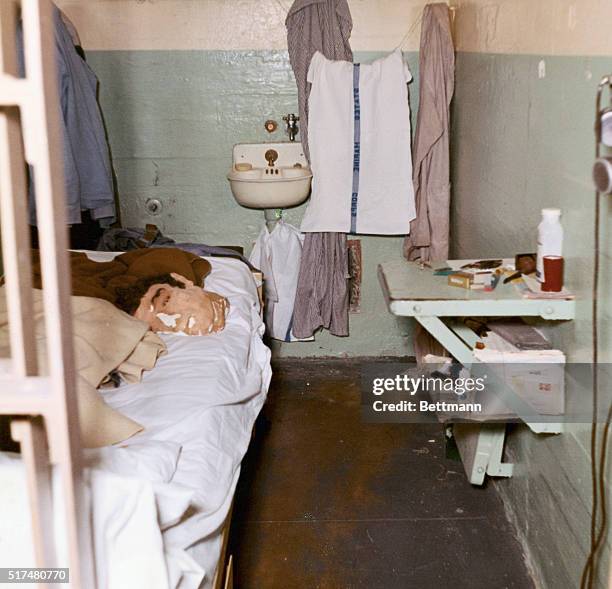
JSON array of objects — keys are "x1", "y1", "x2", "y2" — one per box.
[{"x1": 0, "y1": 252, "x2": 271, "y2": 589}]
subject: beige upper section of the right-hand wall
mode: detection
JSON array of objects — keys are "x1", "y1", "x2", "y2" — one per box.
[{"x1": 454, "y1": 0, "x2": 612, "y2": 55}]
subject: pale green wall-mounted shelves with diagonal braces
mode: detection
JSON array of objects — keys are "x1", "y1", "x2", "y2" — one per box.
[{"x1": 378, "y1": 260, "x2": 576, "y2": 485}]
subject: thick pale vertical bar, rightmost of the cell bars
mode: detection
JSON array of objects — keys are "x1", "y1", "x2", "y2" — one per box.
[{"x1": 22, "y1": 0, "x2": 96, "y2": 589}]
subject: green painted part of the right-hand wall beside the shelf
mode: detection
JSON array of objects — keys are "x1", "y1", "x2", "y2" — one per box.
[{"x1": 451, "y1": 53, "x2": 612, "y2": 589}]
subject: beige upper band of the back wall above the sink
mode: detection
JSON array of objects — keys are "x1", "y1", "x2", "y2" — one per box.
[{"x1": 56, "y1": 0, "x2": 425, "y2": 50}]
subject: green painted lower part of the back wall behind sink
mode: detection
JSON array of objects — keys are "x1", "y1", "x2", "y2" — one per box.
[{"x1": 88, "y1": 51, "x2": 418, "y2": 356}]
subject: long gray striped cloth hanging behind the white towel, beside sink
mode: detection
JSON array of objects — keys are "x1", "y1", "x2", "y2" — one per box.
[{"x1": 285, "y1": 0, "x2": 353, "y2": 338}]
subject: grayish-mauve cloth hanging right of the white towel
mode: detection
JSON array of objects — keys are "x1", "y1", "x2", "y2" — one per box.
[{"x1": 404, "y1": 3, "x2": 455, "y2": 261}]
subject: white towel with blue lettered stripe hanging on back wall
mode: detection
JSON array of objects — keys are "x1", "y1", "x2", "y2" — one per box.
[{"x1": 301, "y1": 50, "x2": 416, "y2": 235}]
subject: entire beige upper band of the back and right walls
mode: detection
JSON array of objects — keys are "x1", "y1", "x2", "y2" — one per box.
[{"x1": 56, "y1": 0, "x2": 612, "y2": 55}]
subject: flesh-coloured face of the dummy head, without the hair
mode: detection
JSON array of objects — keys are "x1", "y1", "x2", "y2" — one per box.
[{"x1": 134, "y1": 273, "x2": 229, "y2": 335}]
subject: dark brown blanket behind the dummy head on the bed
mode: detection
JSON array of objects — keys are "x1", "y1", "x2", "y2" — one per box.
[{"x1": 32, "y1": 248, "x2": 211, "y2": 304}]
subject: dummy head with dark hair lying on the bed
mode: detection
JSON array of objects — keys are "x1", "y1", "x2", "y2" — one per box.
[{"x1": 117, "y1": 273, "x2": 229, "y2": 335}]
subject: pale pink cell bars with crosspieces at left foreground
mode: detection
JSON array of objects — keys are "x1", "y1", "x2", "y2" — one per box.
[{"x1": 0, "y1": 0, "x2": 95, "y2": 589}]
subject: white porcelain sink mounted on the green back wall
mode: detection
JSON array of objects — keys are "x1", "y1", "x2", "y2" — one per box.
[{"x1": 227, "y1": 142, "x2": 312, "y2": 209}]
